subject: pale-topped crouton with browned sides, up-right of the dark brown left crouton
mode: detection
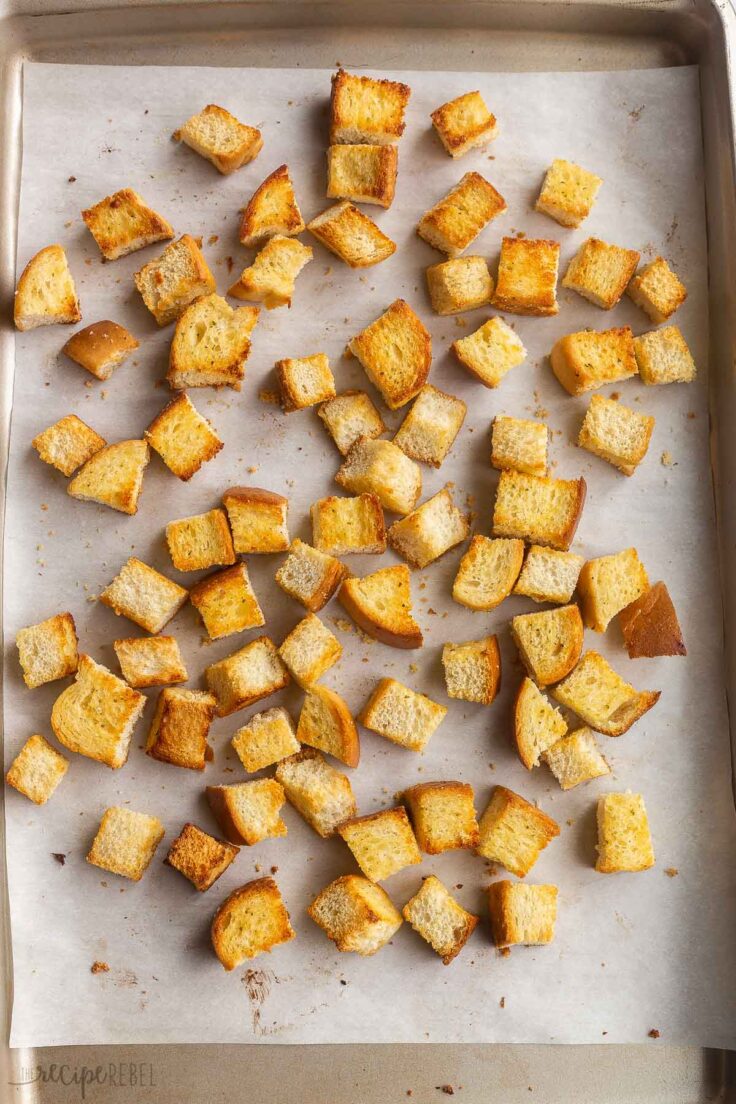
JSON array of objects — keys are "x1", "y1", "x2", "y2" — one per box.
[{"x1": 204, "y1": 636, "x2": 289, "y2": 716}]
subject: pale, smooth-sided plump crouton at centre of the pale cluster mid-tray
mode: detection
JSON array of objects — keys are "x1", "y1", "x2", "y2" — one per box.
[{"x1": 334, "y1": 437, "x2": 422, "y2": 513}]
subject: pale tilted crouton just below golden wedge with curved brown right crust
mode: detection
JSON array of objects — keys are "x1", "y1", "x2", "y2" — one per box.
[{"x1": 276, "y1": 747, "x2": 358, "y2": 839}]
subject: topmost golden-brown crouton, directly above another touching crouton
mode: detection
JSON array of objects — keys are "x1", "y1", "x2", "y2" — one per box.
[{"x1": 330, "y1": 68, "x2": 412, "y2": 146}]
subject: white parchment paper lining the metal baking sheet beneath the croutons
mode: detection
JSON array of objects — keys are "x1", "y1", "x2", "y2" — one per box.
[{"x1": 6, "y1": 58, "x2": 736, "y2": 1047}]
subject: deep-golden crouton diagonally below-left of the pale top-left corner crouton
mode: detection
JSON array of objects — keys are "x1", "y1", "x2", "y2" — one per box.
[{"x1": 82, "y1": 188, "x2": 173, "y2": 261}]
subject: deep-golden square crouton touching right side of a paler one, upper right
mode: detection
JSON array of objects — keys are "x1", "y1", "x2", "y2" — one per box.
[{"x1": 493, "y1": 237, "x2": 559, "y2": 317}]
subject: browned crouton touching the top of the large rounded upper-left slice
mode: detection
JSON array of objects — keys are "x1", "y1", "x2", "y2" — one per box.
[{"x1": 134, "y1": 234, "x2": 216, "y2": 326}]
